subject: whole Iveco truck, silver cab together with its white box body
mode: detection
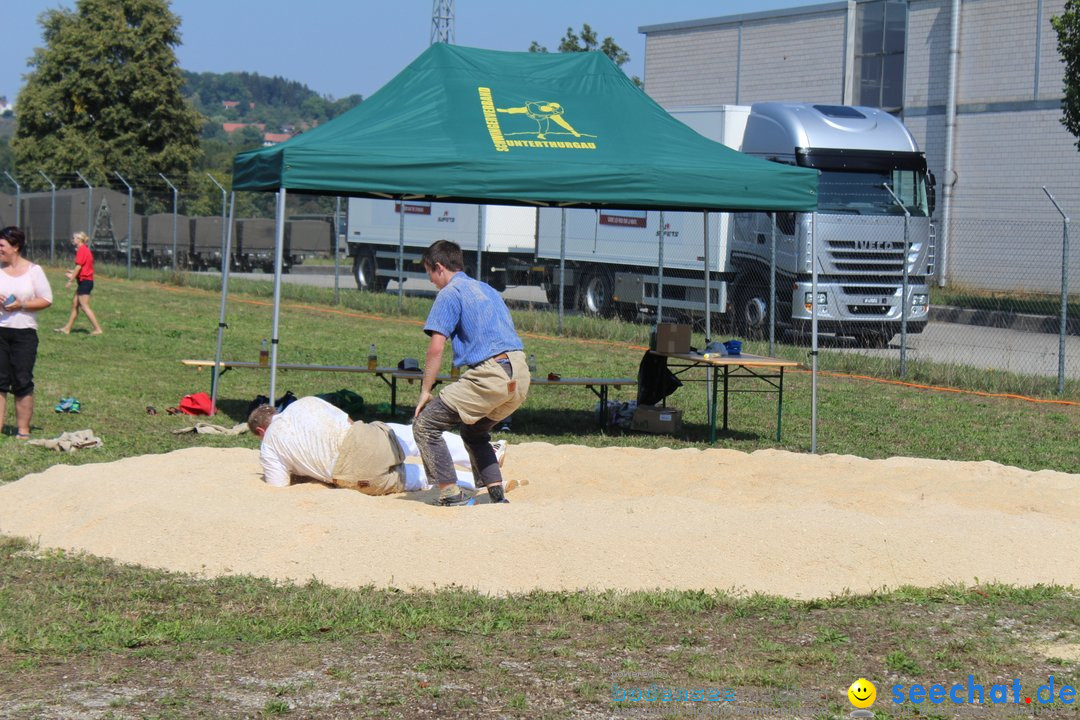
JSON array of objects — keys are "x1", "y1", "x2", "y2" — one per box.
[{"x1": 537, "y1": 103, "x2": 934, "y2": 345}]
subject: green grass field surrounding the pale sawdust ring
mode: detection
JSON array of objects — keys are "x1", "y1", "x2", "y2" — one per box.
[{"x1": 0, "y1": 270, "x2": 1080, "y2": 718}]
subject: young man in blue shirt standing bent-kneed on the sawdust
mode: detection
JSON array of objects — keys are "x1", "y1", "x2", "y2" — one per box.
[{"x1": 413, "y1": 240, "x2": 529, "y2": 505}]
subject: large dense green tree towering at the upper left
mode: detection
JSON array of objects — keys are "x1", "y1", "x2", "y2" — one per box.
[{"x1": 12, "y1": 0, "x2": 202, "y2": 185}]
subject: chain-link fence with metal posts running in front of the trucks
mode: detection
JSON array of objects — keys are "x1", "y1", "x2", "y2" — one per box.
[{"x1": 0, "y1": 183, "x2": 1080, "y2": 397}]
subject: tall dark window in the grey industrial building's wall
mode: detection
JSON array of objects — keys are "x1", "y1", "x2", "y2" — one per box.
[{"x1": 855, "y1": 0, "x2": 907, "y2": 114}]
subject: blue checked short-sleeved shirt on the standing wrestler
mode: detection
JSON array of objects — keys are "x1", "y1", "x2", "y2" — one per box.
[{"x1": 423, "y1": 272, "x2": 525, "y2": 366}]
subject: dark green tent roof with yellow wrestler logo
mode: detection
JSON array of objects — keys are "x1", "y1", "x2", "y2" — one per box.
[{"x1": 233, "y1": 43, "x2": 818, "y2": 210}]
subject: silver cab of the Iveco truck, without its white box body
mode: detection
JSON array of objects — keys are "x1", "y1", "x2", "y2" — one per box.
[{"x1": 731, "y1": 103, "x2": 934, "y2": 345}]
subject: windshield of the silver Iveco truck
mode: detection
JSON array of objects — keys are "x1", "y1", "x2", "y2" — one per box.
[{"x1": 818, "y1": 169, "x2": 928, "y2": 217}]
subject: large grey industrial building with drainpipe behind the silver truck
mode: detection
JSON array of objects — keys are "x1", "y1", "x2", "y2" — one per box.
[{"x1": 639, "y1": 0, "x2": 1080, "y2": 293}]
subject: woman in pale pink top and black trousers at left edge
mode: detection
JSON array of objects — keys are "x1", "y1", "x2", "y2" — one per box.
[{"x1": 0, "y1": 226, "x2": 53, "y2": 439}]
